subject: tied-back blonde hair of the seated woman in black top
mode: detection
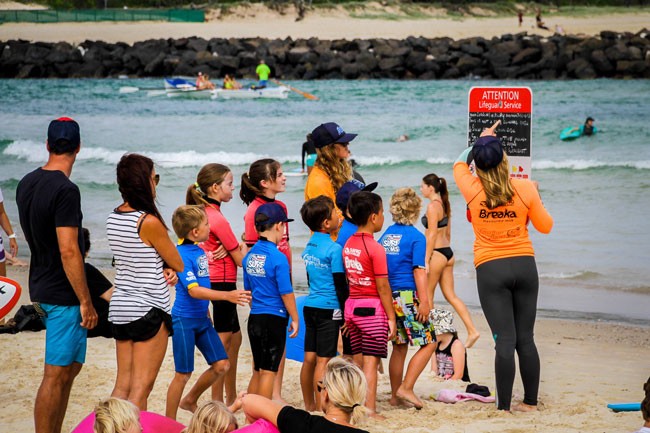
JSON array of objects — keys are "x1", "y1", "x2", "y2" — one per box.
[{"x1": 323, "y1": 358, "x2": 368, "y2": 424}]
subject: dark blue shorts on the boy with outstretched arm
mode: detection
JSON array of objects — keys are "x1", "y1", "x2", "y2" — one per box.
[{"x1": 172, "y1": 315, "x2": 228, "y2": 373}]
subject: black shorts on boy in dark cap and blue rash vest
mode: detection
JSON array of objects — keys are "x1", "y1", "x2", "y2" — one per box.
[{"x1": 248, "y1": 314, "x2": 289, "y2": 372}]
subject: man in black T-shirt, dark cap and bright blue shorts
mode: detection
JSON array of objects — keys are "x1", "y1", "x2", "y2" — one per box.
[{"x1": 16, "y1": 117, "x2": 97, "y2": 433}]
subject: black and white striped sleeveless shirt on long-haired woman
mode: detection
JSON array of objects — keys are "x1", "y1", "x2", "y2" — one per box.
[{"x1": 106, "y1": 210, "x2": 171, "y2": 325}]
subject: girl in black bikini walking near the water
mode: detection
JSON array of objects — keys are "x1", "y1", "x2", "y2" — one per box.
[{"x1": 420, "y1": 173, "x2": 480, "y2": 349}]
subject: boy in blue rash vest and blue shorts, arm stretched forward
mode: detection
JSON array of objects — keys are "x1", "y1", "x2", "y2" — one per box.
[{"x1": 165, "y1": 206, "x2": 250, "y2": 419}]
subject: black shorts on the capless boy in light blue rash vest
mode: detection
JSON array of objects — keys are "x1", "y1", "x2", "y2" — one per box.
[{"x1": 302, "y1": 307, "x2": 343, "y2": 358}]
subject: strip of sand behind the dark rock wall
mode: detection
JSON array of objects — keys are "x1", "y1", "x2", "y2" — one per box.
[{"x1": 0, "y1": 2, "x2": 650, "y2": 44}]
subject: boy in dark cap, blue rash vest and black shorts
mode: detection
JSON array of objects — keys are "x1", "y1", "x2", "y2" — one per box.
[{"x1": 243, "y1": 203, "x2": 298, "y2": 398}]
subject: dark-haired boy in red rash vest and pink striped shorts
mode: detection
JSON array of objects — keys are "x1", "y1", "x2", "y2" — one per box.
[{"x1": 343, "y1": 191, "x2": 395, "y2": 418}]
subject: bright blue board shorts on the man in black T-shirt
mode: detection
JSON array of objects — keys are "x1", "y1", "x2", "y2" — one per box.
[{"x1": 38, "y1": 303, "x2": 88, "y2": 367}]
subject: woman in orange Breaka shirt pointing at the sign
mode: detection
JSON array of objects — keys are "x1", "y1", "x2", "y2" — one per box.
[{"x1": 454, "y1": 121, "x2": 553, "y2": 411}]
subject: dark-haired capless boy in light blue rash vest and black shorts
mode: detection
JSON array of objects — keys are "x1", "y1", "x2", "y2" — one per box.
[{"x1": 300, "y1": 195, "x2": 348, "y2": 412}]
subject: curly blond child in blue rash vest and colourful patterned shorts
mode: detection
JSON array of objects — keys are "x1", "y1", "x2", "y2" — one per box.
[{"x1": 379, "y1": 188, "x2": 436, "y2": 409}]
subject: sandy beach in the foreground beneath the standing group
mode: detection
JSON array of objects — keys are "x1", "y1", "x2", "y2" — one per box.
[{"x1": 0, "y1": 267, "x2": 650, "y2": 433}]
